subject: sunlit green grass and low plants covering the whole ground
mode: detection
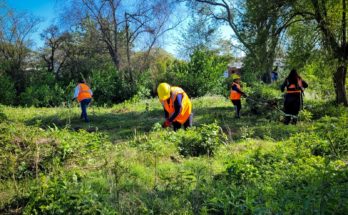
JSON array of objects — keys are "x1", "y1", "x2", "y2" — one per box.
[{"x1": 0, "y1": 96, "x2": 348, "y2": 214}]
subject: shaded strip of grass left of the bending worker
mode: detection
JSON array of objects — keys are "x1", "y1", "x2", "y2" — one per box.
[{"x1": 25, "y1": 110, "x2": 163, "y2": 142}]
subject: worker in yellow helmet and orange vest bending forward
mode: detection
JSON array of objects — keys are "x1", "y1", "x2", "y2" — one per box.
[{"x1": 157, "y1": 83, "x2": 192, "y2": 131}]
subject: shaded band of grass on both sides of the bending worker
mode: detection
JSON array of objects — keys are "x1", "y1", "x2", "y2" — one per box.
[{"x1": 26, "y1": 106, "x2": 301, "y2": 142}]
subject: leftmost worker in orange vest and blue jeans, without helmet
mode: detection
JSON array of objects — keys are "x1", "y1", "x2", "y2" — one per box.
[{"x1": 73, "y1": 79, "x2": 93, "y2": 122}]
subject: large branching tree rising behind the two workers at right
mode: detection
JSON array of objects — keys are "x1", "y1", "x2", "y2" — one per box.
[{"x1": 191, "y1": 0, "x2": 293, "y2": 82}]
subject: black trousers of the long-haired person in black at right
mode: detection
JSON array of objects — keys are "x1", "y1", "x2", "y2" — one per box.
[{"x1": 284, "y1": 93, "x2": 302, "y2": 125}]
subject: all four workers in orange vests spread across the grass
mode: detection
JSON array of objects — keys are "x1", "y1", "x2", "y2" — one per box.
[{"x1": 73, "y1": 69, "x2": 308, "y2": 131}]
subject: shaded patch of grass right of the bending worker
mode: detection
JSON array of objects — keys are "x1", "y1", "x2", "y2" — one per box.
[{"x1": 194, "y1": 106, "x2": 307, "y2": 141}]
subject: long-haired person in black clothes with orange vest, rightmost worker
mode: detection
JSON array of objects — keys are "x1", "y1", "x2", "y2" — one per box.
[{"x1": 280, "y1": 69, "x2": 308, "y2": 125}]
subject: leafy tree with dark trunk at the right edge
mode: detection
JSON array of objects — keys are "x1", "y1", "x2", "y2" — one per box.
[{"x1": 278, "y1": 0, "x2": 348, "y2": 106}]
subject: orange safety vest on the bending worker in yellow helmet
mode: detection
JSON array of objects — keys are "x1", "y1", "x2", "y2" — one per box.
[{"x1": 161, "y1": 87, "x2": 192, "y2": 124}]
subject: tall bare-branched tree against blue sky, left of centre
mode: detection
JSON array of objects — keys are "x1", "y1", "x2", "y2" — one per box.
[{"x1": 61, "y1": 0, "x2": 178, "y2": 81}]
